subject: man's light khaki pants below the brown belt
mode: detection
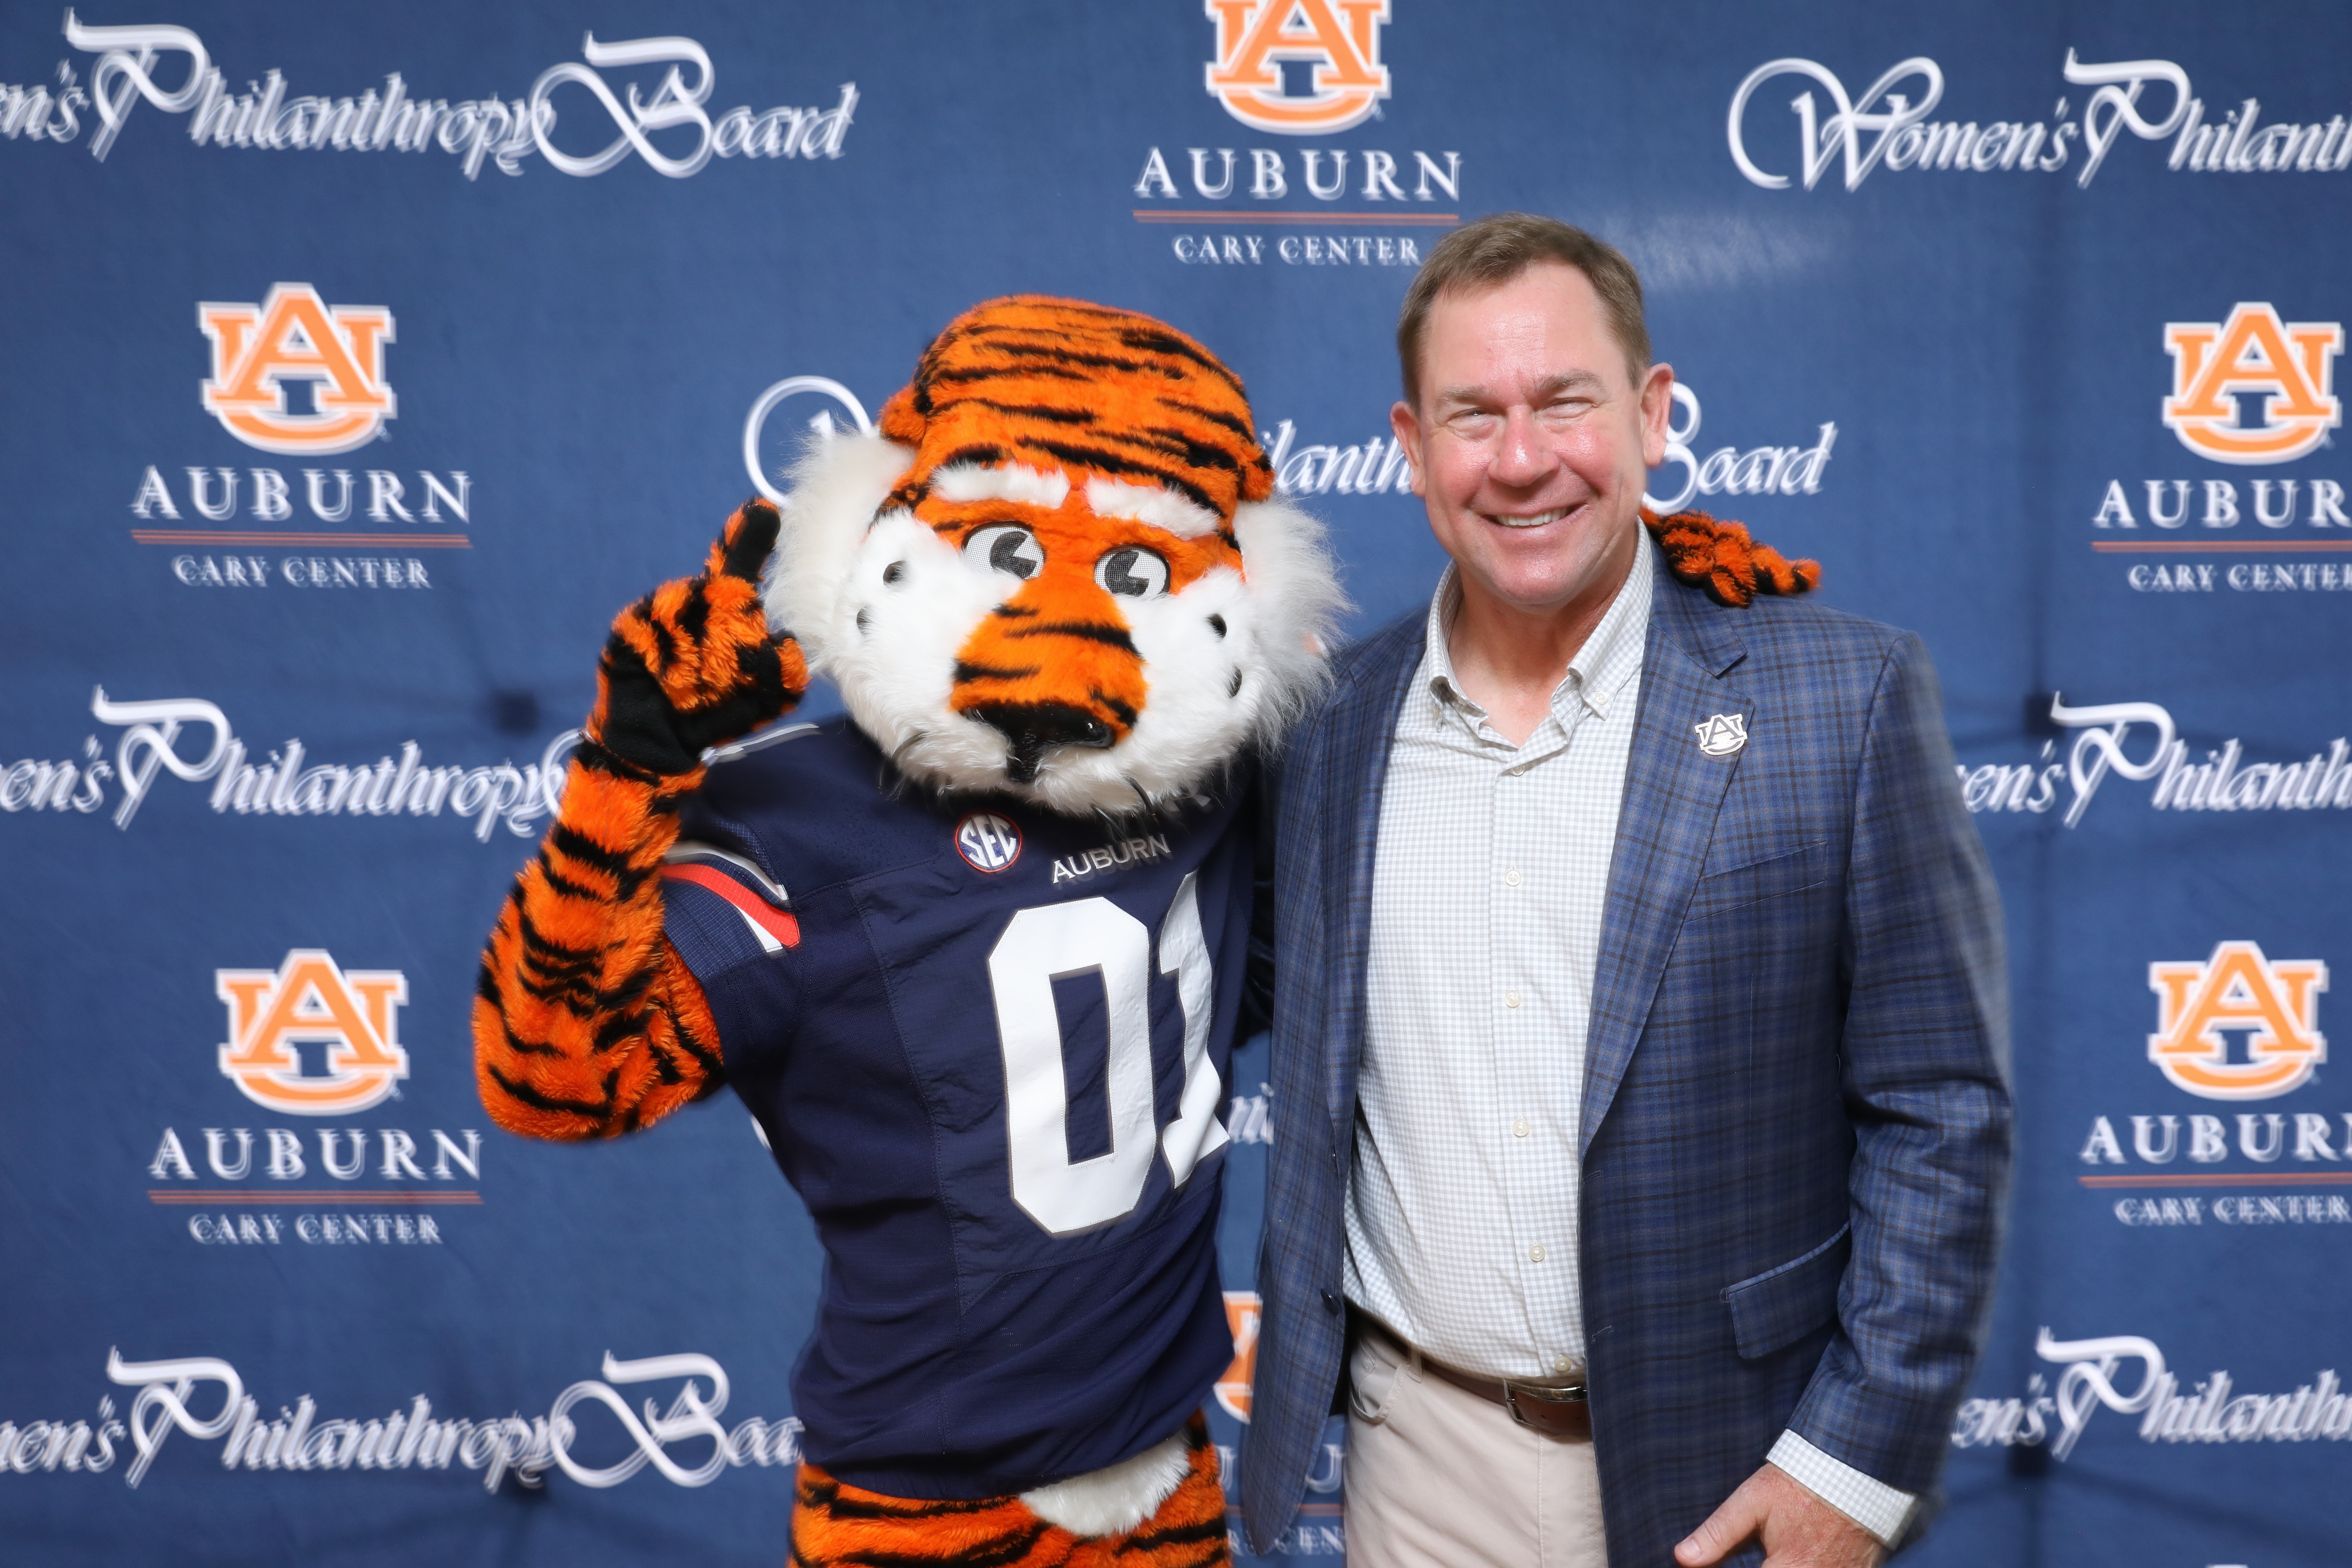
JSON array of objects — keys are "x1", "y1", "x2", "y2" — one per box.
[{"x1": 1348, "y1": 1333, "x2": 1609, "y2": 1568}]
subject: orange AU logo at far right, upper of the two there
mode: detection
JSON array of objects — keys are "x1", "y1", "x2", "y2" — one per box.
[{"x1": 2164, "y1": 303, "x2": 2345, "y2": 463}]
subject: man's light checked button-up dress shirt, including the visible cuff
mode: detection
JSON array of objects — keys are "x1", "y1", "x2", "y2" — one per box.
[{"x1": 1345, "y1": 529, "x2": 1912, "y2": 1545}]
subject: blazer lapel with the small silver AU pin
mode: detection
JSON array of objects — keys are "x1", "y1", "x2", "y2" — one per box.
[{"x1": 1578, "y1": 567, "x2": 1757, "y2": 1154}]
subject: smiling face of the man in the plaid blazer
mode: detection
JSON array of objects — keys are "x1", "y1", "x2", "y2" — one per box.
[{"x1": 1390, "y1": 261, "x2": 1675, "y2": 614}]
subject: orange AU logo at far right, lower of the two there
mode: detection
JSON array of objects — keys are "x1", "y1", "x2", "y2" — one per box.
[{"x1": 2147, "y1": 943, "x2": 2329, "y2": 1100}]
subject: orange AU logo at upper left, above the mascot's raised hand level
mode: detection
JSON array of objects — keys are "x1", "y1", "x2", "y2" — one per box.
[{"x1": 195, "y1": 282, "x2": 398, "y2": 456}]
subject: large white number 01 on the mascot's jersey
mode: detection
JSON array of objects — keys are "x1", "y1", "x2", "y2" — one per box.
[{"x1": 988, "y1": 872, "x2": 1228, "y2": 1237}]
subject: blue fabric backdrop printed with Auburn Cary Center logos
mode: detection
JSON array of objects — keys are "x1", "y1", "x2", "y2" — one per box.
[{"x1": 0, "y1": 0, "x2": 2352, "y2": 1568}]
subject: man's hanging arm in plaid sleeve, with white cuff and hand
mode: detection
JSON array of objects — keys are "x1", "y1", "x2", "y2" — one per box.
[{"x1": 1675, "y1": 635, "x2": 2009, "y2": 1568}]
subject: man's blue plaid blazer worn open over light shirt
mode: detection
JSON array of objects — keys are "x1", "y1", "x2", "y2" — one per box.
[{"x1": 1239, "y1": 557, "x2": 2011, "y2": 1568}]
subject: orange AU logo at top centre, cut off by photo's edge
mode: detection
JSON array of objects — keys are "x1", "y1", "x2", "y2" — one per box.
[{"x1": 1206, "y1": 0, "x2": 1388, "y2": 136}]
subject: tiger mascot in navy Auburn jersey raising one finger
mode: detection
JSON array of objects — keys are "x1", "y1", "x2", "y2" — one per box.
[{"x1": 475, "y1": 296, "x2": 1340, "y2": 1568}]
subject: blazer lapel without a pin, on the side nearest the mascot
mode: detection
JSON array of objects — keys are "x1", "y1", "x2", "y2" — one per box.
[{"x1": 1317, "y1": 621, "x2": 1428, "y2": 1149}]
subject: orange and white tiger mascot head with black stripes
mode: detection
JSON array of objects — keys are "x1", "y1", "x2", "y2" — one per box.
[{"x1": 767, "y1": 294, "x2": 1340, "y2": 813}]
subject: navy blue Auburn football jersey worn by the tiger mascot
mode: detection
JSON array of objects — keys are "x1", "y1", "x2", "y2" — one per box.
[{"x1": 663, "y1": 722, "x2": 1258, "y2": 1498}]
